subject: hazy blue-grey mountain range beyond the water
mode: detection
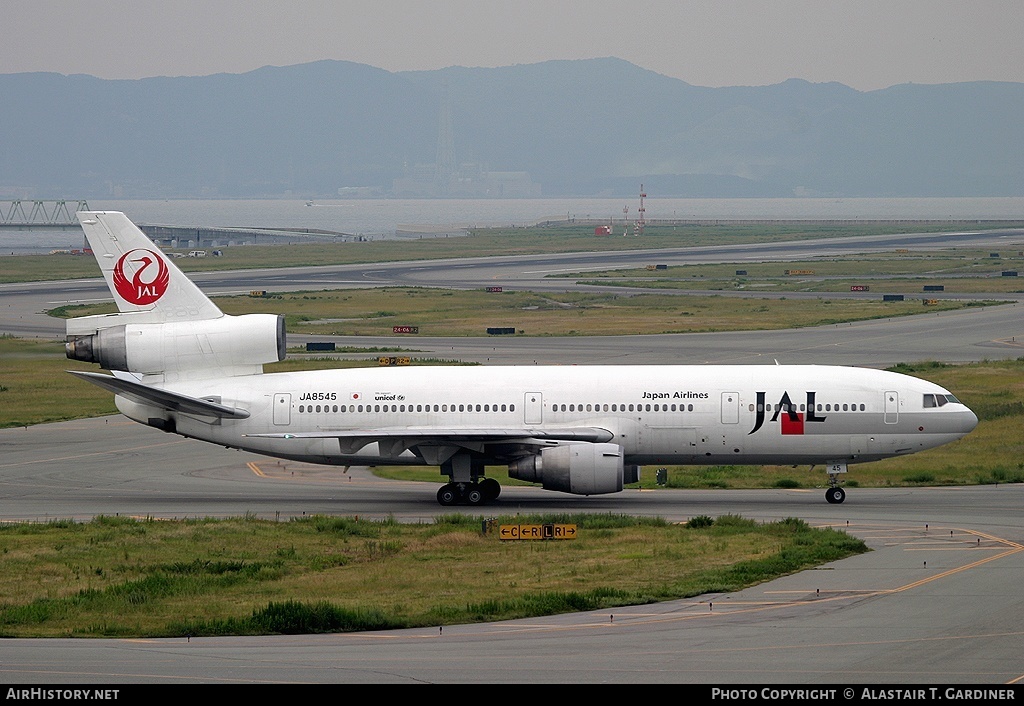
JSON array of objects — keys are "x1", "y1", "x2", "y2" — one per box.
[{"x1": 0, "y1": 58, "x2": 1024, "y2": 199}]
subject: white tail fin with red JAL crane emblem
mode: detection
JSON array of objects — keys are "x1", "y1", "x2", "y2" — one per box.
[{"x1": 77, "y1": 211, "x2": 223, "y2": 321}]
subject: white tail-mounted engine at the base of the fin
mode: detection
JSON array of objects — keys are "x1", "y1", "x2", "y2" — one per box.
[{"x1": 65, "y1": 314, "x2": 287, "y2": 375}]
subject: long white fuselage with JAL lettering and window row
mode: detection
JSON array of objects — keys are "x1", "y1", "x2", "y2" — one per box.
[{"x1": 118, "y1": 366, "x2": 977, "y2": 465}]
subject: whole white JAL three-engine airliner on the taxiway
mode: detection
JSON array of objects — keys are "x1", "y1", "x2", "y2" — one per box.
[{"x1": 66, "y1": 211, "x2": 978, "y2": 505}]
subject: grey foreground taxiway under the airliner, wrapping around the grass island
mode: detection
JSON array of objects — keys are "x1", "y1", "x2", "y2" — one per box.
[{"x1": 0, "y1": 417, "x2": 1024, "y2": 688}]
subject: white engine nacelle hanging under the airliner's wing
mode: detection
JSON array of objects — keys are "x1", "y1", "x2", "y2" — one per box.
[{"x1": 509, "y1": 443, "x2": 639, "y2": 495}]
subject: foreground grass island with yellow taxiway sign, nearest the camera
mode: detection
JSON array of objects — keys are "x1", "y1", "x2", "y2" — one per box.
[{"x1": 0, "y1": 515, "x2": 866, "y2": 637}]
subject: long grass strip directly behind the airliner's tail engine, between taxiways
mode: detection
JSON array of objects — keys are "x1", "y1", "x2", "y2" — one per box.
[{"x1": 54, "y1": 287, "x2": 994, "y2": 338}]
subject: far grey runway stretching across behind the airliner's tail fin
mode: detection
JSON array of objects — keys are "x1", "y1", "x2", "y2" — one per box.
[{"x1": 6, "y1": 229, "x2": 1024, "y2": 337}]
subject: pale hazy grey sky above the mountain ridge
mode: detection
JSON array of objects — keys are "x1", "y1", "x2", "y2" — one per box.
[{"x1": 8, "y1": 0, "x2": 1024, "y2": 90}]
